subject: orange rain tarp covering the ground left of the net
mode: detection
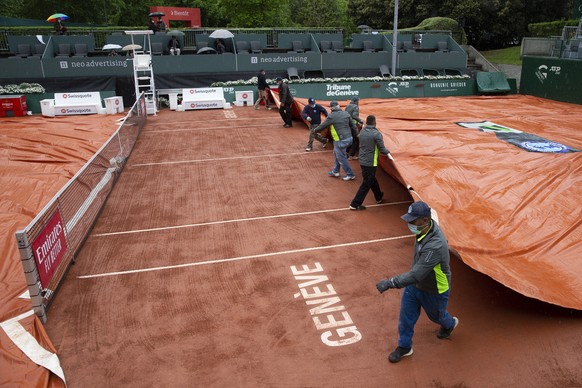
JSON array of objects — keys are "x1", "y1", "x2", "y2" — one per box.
[{"x1": 0, "y1": 115, "x2": 120, "y2": 387}]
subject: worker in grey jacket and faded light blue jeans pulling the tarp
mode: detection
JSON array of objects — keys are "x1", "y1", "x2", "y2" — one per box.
[{"x1": 313, "y1": 101, "x2": 358, "y2": 181}]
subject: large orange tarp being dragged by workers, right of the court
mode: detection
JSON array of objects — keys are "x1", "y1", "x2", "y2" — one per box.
[{"x1": 356, "y1": 95, "x2": 582, "y2": 310}]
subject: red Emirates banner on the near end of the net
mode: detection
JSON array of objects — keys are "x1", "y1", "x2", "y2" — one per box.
[{"x1": 32, "y1": 210, "x2": 67, "y2": 288}]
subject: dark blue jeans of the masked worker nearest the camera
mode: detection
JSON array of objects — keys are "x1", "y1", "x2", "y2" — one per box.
[{"x1": 398, "y1": 286, "x2": 455, "y2": 348}]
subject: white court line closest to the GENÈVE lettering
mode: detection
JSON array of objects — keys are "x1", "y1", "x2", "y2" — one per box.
[{"x1": 77, "y1": 234, "x2": 414, "y2": 279}]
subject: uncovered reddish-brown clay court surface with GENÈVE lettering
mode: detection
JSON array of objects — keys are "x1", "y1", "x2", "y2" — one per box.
[{"x1": 38, "y1": 104, "x2": 582, "y2": 387}]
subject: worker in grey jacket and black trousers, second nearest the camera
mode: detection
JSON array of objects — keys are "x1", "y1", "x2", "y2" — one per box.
[{"x1": 350, "y1": 115, "x2": 390, "y2": 210}]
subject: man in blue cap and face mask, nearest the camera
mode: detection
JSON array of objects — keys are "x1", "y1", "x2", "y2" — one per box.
[{"x1": 376, "y1": 201, "x2": 459, "y2": 363}]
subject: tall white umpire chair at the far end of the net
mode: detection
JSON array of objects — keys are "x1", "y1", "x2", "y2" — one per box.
[{"x1": 125, "y1": 30, "x2": 158, "y2": 116}]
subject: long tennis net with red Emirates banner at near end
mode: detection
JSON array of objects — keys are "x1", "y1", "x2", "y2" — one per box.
[{"x1": 16, "y1": 94, "x2": 147, "y2": 323}]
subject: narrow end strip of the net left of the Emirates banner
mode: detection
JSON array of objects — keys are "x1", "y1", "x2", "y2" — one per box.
[{"x1": 16, "y1": 230, "x2": 46, "y2": 323}]
